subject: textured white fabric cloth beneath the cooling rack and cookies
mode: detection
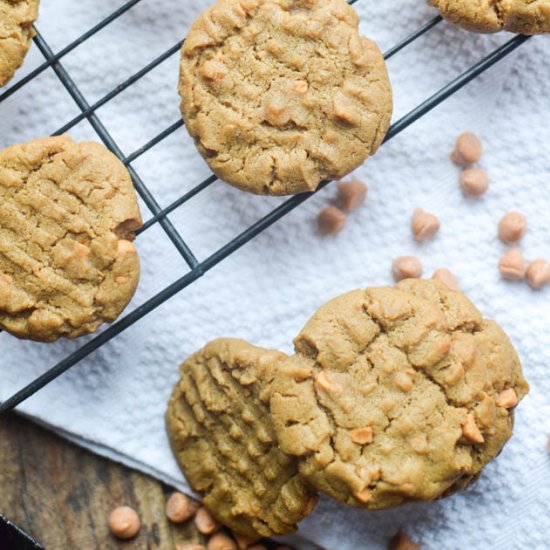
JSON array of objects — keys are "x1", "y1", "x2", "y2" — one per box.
[{"x1": 0, "y1": 0, "x2": 550, "y2": 550}]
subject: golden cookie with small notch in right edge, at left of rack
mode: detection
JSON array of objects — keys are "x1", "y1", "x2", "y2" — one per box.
[{"x1": 0, "y1": 136, "x2": 141, "y2": 342}]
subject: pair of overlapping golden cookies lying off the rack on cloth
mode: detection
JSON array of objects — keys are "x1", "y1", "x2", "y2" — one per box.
[{"x1": 167, "y1": 280, "x2": 528, "y2": 536}]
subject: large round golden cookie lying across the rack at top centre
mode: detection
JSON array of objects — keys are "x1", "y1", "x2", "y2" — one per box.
[{"x1": 179, "y1": 0, "x2": 392, "y2": 195}]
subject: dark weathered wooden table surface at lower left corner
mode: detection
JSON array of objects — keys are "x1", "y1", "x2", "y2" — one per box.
[{"x1": 0, "y1": 415, "x2": 207, "y2": 550}]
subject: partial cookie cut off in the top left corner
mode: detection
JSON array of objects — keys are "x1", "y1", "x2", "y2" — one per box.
[{"x1": 0, "y1": 0, "x2": 39, "y2": 88}]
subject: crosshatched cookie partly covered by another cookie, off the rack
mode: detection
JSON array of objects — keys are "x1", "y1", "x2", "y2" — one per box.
[{"x1": 166, "y1": 339, "x2": 316, "y2": 536}]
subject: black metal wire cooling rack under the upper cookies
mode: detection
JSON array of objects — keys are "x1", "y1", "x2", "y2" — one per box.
[{"x1": 0, "y1": 0, "x2": 529, "y2": 414}]
